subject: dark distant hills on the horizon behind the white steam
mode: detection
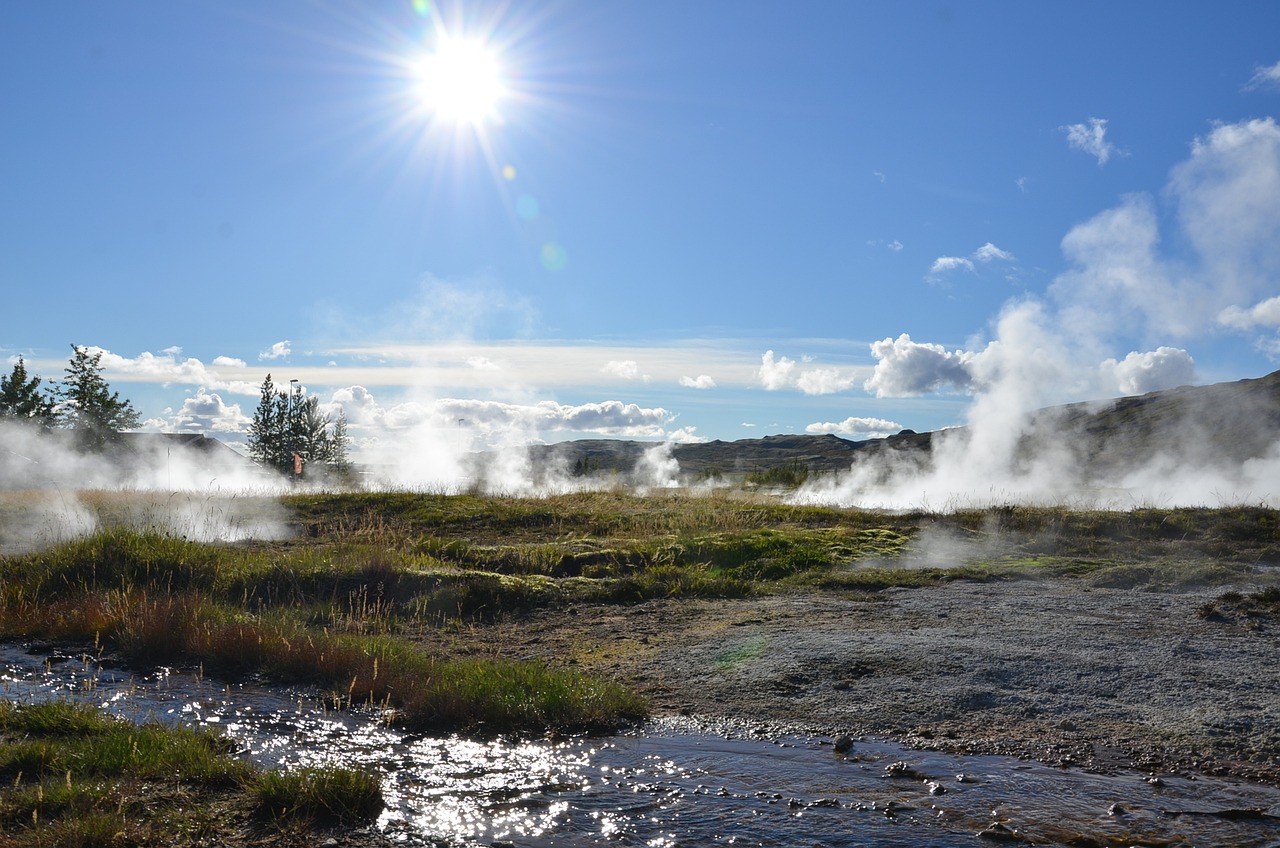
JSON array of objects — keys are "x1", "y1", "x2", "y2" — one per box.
[{"x1": 530, "y1": 371, "x2": 1280, "y2": 480}]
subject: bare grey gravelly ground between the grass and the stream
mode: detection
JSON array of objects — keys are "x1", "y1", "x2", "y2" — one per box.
[{"x1": 454, "y1": 579, "x2": 1280, "y2": 784}]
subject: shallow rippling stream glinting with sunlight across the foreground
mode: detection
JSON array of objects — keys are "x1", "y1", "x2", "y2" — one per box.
[{"x1": 0, "y1": 644, "x2": 1280, "y2": 848}]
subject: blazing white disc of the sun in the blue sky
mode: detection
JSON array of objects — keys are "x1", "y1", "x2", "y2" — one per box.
[{"x1": 417, "y1": 37, "x2": 504, "y2": 124}]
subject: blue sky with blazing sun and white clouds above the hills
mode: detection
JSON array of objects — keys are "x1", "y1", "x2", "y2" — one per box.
[{"x1": 0, "y1": 0, "x2": 1280, "y2": 456}]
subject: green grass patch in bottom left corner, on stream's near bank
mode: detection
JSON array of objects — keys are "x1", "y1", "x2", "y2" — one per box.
[{"x1": 0, "y1": 701, "x2": 383, "y2": 847}]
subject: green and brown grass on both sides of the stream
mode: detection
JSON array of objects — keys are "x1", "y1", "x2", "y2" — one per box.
[{"x1": 0, "y1": 492, "x2": 1280, "y2": 845}]
